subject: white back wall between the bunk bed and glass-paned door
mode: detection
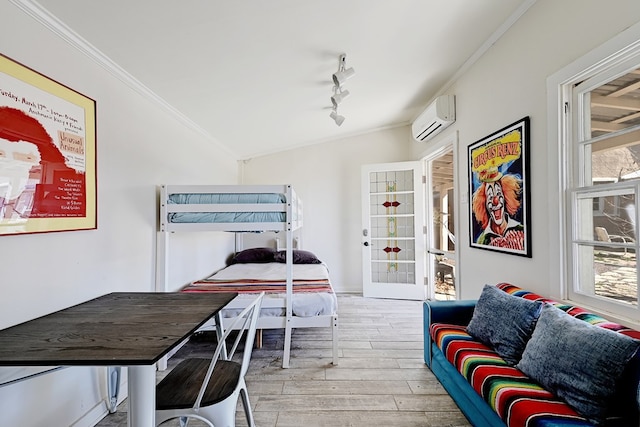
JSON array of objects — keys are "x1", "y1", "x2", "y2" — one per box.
[{"x1": 243, "y1": 126, "x2": 413, "y2": 293}]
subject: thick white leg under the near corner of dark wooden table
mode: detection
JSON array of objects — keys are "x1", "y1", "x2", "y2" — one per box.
[{"x1": 128, "y1": 365, "x2": 156, "y2": 427}]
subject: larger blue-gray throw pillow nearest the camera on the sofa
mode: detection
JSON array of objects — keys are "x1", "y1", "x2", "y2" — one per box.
[{"x1": 516, "y1": 304, "x2": 640, "y2": 424}]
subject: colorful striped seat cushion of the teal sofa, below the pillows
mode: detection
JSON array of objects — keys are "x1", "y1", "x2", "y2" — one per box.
[{"x1": 430, "y1": 323, "x2": 592, "y2": 427}]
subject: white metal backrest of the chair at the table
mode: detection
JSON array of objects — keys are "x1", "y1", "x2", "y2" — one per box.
[{"x1": 194, "y1": 292, "x2": 264, "y2": 408}]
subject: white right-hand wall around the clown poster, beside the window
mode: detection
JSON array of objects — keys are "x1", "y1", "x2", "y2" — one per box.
[{"x1": 414, "y1": 0, "x2": 640, "y2": 298}]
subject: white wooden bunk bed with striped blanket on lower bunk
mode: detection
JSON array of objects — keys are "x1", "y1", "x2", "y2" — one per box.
[{"x1": 156, "y1": 185, "x2": 338, "y2": 368}]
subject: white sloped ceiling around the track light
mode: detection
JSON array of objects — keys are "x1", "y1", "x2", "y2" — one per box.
[{"x1": 28, "y1": 0, "x2": 535, "y2": 159}]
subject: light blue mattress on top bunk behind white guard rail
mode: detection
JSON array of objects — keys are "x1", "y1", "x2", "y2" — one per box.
[{"x1": 167, "y1": 193, "x2": 287, "y2": 223}]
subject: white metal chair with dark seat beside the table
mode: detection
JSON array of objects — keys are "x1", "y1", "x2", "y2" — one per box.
[{"x1": 156, "y1": 292, "x2": 264, "y2": 427}]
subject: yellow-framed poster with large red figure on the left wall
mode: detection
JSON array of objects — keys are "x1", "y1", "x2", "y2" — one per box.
[{"x1": 0, "y1": 54, "x2": 97, "y2": 235}]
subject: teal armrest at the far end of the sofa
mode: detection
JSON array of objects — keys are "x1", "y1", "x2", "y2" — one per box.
[{"x1": 422, "y1": 300, "x2": 477, "y2": 367}]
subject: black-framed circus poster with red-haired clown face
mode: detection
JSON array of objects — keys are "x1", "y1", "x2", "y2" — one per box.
[{"x1": 468, "y1": 117, "x2": 531, "y2": 257}]
